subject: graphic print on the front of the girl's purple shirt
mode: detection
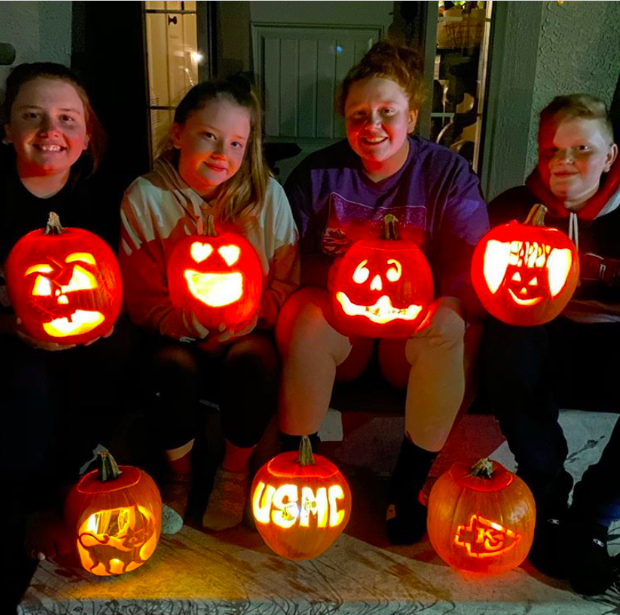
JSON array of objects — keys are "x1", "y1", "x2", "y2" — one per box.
[{"x1": 321, "y1": 192, "x2": 426, "y2": 258}]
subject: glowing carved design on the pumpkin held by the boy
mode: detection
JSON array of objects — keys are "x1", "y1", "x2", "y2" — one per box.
[{"x1": 484, "y1": 240, "x2": 572, "y2": 306}]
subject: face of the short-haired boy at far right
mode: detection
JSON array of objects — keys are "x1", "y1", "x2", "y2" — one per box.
[{"x1": 538, "y1": 118, "x2": 618, "y2": 205}]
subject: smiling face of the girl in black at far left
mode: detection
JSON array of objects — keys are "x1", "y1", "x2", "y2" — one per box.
[{"x1": 5, "y1": 77, "x2": 88, "y2": 177}]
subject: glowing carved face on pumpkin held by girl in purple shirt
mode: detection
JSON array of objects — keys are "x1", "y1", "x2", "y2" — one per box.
[{"x1": 336, "y1": 258, "x2": 423, "y2": 324}]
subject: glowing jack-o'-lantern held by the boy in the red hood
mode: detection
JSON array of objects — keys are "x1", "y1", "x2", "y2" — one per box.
[{"x1": 471, "y1": 205, "x2": 579, "y2": 326}]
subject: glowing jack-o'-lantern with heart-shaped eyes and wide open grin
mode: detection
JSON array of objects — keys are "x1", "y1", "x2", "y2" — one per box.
[{"x1": 168, "y1": 216, "x2": 263, "y2": 329}]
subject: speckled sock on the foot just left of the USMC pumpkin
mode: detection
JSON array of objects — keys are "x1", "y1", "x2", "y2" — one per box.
[{"x1": 202, "y1": 466, "x2": 249, "y2": 532}]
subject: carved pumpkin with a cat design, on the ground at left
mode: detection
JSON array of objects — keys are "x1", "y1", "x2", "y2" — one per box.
[{"x1": 65, "y1": 447, "x2": 162, "y2": 576}]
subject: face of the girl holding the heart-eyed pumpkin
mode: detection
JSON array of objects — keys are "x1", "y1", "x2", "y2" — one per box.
[{"x1": 172, "y1": 97, "x2": 252, "y2": 197}]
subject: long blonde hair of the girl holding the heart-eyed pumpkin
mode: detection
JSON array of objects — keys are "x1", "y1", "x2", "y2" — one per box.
[{"x1": 173, "y1": 78, "x2": 270, "y2": 222}]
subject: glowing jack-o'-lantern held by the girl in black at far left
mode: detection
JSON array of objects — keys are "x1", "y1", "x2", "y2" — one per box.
[{"x1": 6, "y1": 212, "x2": 122, "y2": 344}]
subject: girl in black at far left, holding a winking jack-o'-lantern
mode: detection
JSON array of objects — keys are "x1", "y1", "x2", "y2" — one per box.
[{"x1": 0, "y1": 62, "x2": 123, "y2": 556}]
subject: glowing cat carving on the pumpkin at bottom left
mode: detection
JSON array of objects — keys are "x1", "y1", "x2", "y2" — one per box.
[{"x1": 78, "y1": 505, "x2": 157, "y2": 576}]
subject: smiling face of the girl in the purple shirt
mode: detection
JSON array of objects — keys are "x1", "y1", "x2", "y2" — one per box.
[{"x1": 344, "y1": 77, "x2": 418, "y2": 180}]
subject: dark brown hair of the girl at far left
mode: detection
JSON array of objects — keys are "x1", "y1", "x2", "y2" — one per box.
[{"x1": 3, "y1": 62, "x2": 106, "y2": 172}]
